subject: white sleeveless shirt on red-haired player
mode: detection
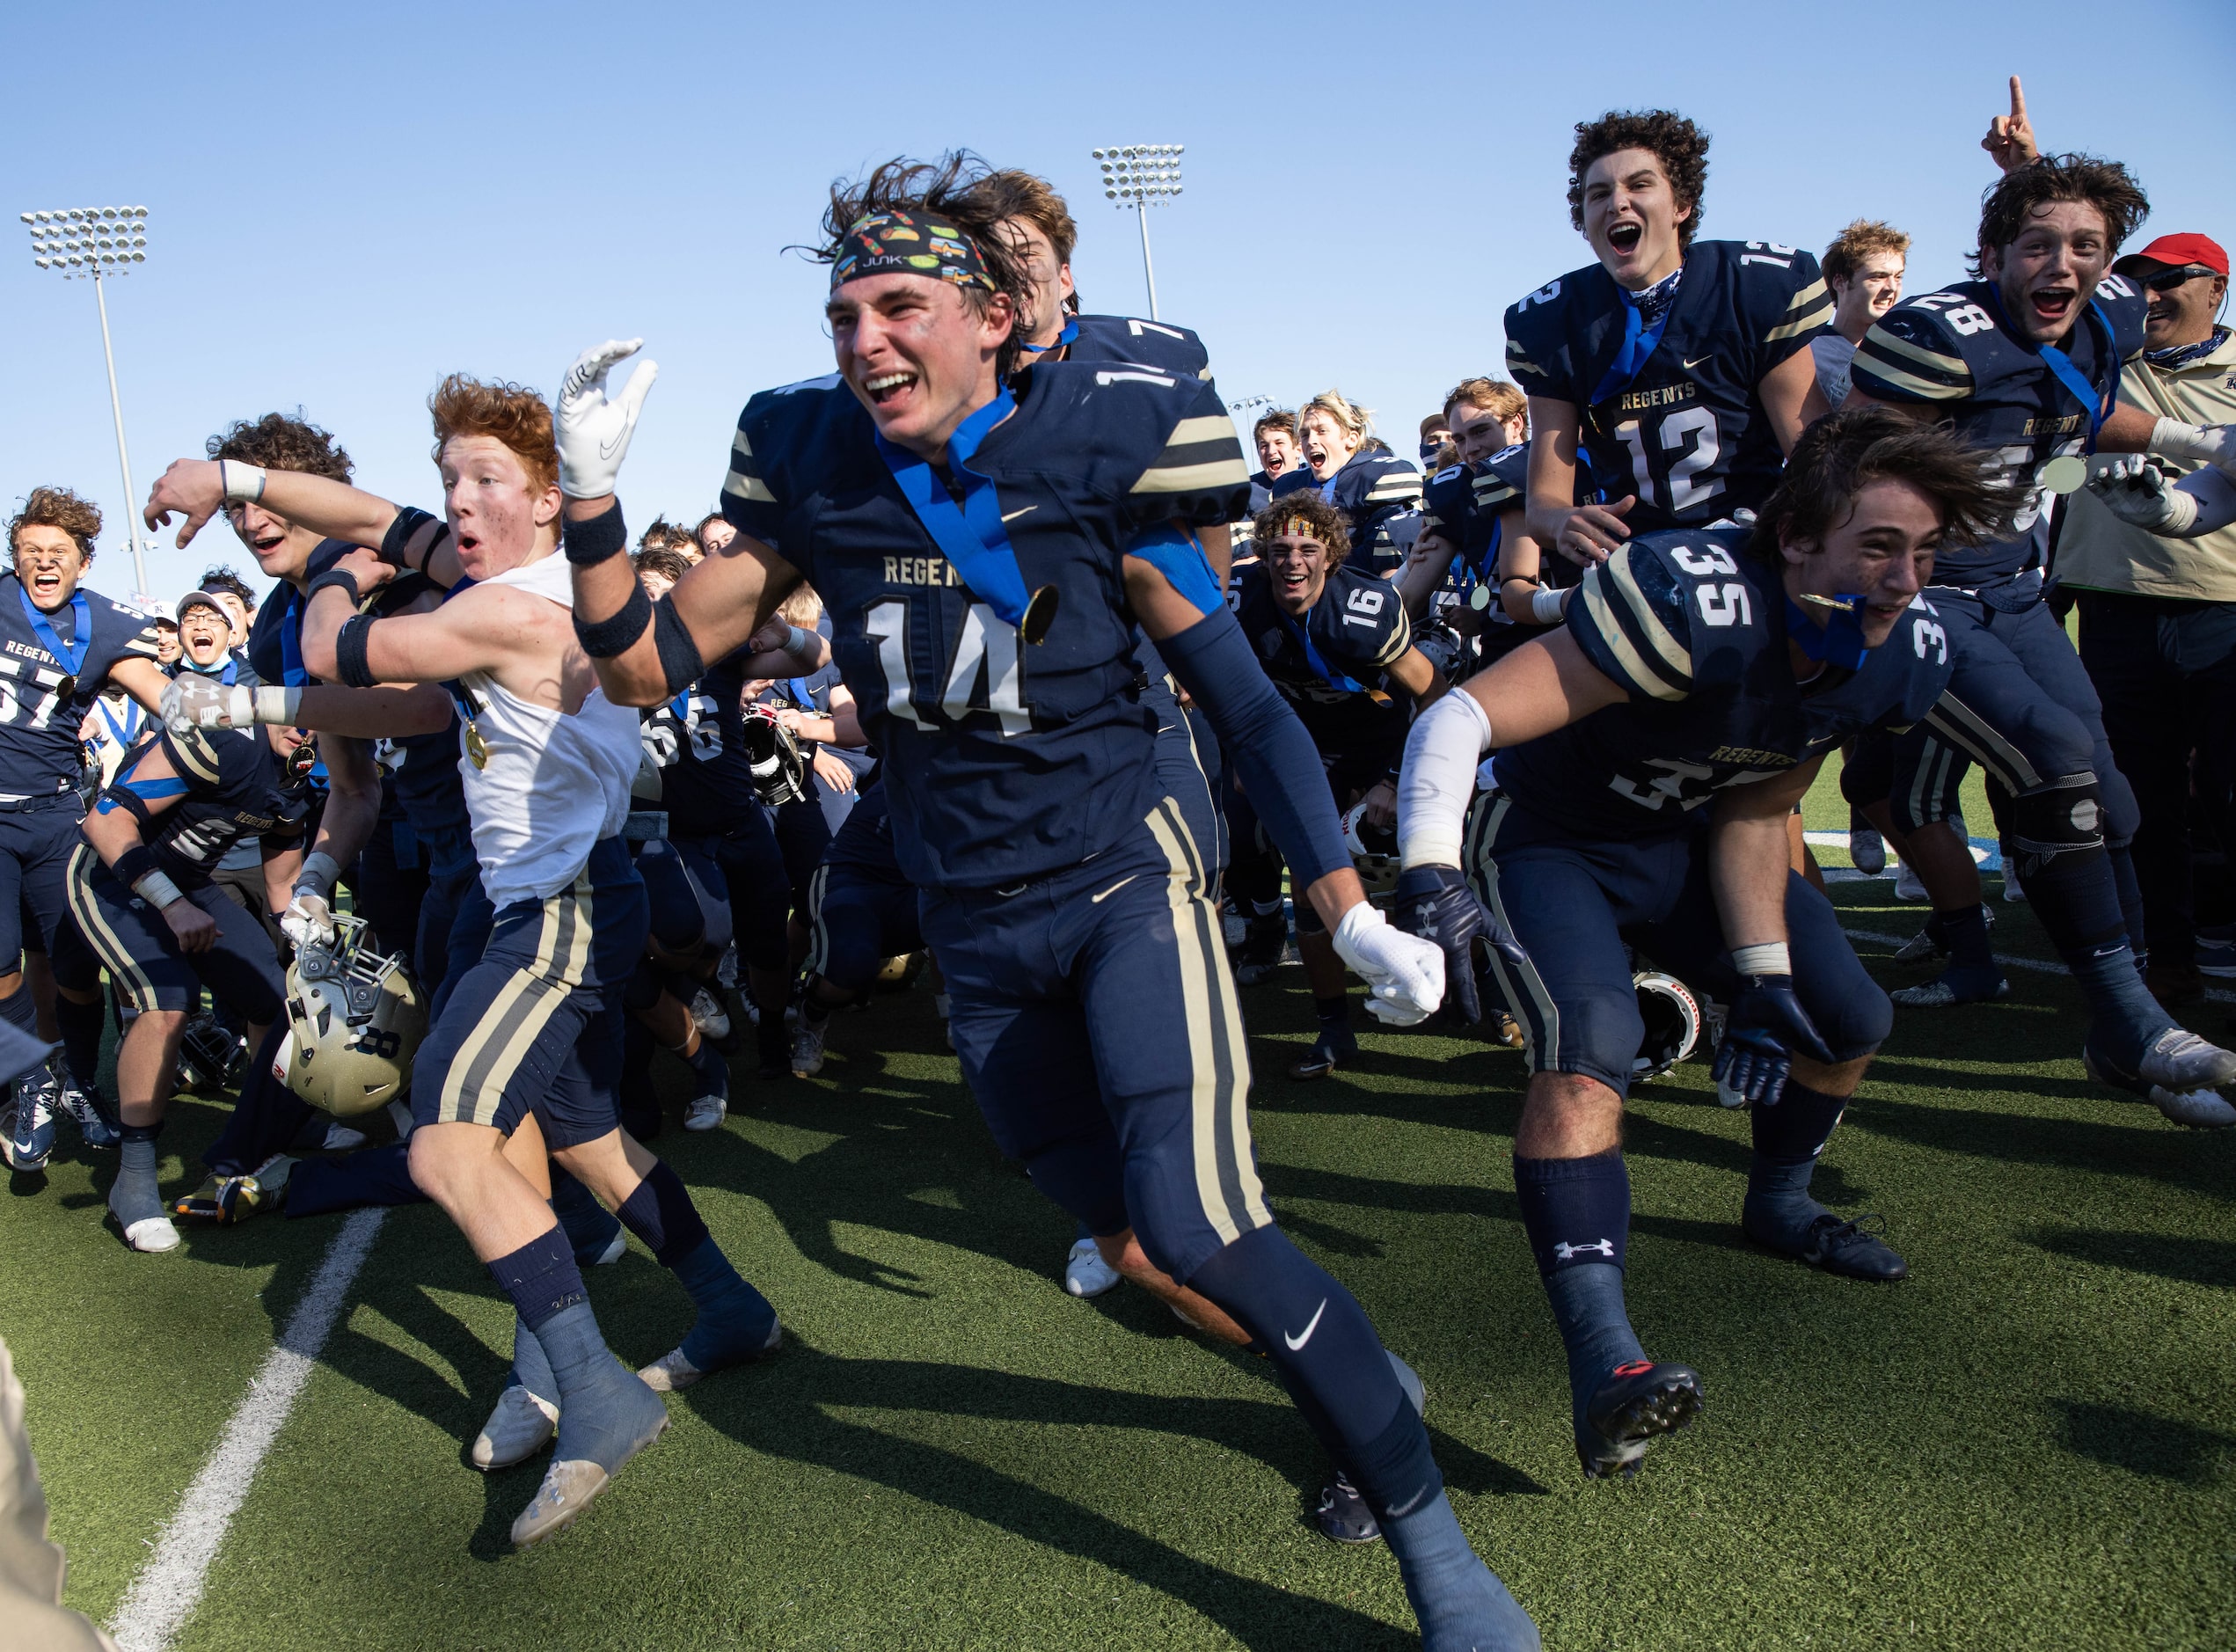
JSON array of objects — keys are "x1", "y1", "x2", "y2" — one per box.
[{"x1": 458, "y1": 550, "x2": 642, "y2": 910}]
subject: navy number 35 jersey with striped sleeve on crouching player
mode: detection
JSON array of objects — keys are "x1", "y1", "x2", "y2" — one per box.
[{"x1": 1492, "y1": 530, "x2": 1950, "y2": 841}]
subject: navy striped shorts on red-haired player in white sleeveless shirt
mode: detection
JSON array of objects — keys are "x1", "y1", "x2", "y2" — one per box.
[{"x1": 412, "y1": 838, "x2": 648, "y2": 1147}]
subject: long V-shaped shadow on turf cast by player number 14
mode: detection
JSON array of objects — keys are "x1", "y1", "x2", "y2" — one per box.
[{"x1": 661, "y1": 1343, "x2": 1545, "y2": 1648}]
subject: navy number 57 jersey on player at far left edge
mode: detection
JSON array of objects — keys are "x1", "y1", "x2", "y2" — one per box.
[{"x1": 0, "y1": 573, "x2": 157, "y2": 798}]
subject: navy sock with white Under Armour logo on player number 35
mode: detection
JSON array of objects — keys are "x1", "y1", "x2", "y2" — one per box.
[{"x1": 1514, "y1": 1147, "x2": 1646, "y2": 1433}]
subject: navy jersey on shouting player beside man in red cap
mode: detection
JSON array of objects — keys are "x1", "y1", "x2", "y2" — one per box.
[{"x1": 1849, "y1": 275, "x2": 2149, "y2": 590}]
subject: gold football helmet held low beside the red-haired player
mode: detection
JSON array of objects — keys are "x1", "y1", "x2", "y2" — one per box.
[{"x1": 280, "y1": 912, "x2": 427, "y2": 1118}]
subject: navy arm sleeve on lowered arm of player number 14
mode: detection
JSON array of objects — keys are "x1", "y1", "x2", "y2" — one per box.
[{"x1": 1156, "y1": 608, "x2": 1350, "y2": 892}]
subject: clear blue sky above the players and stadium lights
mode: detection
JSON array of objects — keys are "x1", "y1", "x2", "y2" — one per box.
[{"x1": 0, "y1": 0, "x2": 2236, "y2": 597}]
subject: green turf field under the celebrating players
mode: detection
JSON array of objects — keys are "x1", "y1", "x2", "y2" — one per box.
[{"x1": 0, "y1": 769, "x2": 2236, "y2": 1649}]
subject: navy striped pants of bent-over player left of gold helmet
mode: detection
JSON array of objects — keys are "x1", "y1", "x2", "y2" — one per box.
[{"x1": 67, "y1": 841, "x2": 286, "y2": 1026}]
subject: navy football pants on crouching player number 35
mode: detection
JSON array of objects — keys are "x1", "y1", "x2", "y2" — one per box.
[{"x1": 1467, "y1": 792, "x2": 1894, "y2": 1095}]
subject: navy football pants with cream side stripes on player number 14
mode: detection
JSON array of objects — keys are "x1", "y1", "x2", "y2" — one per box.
[{"x1": 921, "y1": 798, "x2": 1272, "y2": 1283}]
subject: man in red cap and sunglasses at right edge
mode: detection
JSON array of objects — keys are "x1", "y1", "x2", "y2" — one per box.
[{"x1": 2055, "y1": 235, "x2": 2236, "y2": 1004}]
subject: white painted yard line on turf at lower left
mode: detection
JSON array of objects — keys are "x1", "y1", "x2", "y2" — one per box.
[{"x1": 110, "y1": 1207, "x2": 387, "y2": 1652}]
